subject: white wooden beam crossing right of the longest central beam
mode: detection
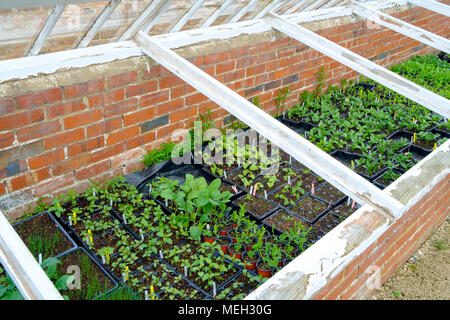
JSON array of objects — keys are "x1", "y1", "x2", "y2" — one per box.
[{"x1": 267, "y1": 13, "x2": 450, "y2": 118}]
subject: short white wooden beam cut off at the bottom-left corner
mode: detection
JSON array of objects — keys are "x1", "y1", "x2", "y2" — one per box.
[{"x1": 0, "y1": 211, "x2": 63, "y2": 300}]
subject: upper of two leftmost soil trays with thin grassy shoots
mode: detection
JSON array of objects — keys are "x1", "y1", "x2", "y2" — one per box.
[{"x1": 14, "y1": 214, "x2": 73, "y2": 259}]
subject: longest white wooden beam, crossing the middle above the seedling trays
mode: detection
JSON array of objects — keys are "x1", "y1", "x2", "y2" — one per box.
[{"x1": 134, "y1": 31, "x2": 401, "y2": 217}]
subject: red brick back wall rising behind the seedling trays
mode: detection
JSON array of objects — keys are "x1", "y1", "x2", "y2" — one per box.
[{"x1": 0, "y1": 9, "x2": 450, "y2": 218}]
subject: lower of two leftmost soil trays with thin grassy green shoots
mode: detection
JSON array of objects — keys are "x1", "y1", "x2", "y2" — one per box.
[{"x1": 59, "y1": 250, "x2": 115, "y2": 300}]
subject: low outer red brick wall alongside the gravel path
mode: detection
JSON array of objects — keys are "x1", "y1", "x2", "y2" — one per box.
[{"x1": 313, "y1": 174, "x2": 450, "y2": 300}]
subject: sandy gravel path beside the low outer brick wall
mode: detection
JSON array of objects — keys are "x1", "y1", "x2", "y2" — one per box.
[{"x1": 372, "y1": 216, "x2": 450, "y2": 300}]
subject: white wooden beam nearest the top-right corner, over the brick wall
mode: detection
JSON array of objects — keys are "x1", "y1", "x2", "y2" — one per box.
[{"x1": 351, "y1": 1, "x2": 450, "y2": 53}]
